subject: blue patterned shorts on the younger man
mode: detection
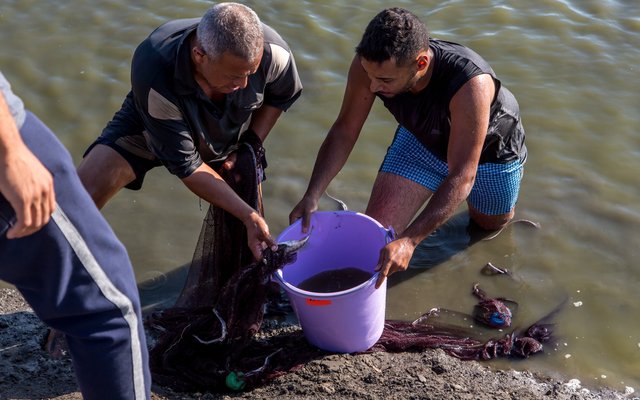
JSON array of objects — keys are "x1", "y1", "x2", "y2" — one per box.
[{"x1": 380, "y1": 126, "x2": 524, "y2": 215}]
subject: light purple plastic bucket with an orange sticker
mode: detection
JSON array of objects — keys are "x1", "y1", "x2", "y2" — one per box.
[{"x1": 274, "y1": 211, "x2": 393, "y2": 353}]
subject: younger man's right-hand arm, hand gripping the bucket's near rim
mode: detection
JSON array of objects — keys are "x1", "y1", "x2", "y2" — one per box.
[{"x1": 376, "y1": 75, "x2": 495, "y2": 287}]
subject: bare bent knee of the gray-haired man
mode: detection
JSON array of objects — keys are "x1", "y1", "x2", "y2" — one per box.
[{"x1": 78, "y1": 144, "x2": 135, "y2": 208}]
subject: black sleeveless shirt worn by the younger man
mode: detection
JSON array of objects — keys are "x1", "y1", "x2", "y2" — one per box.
[{"x1": 378, "y1": 39, "x2": 527, "y2": 164}]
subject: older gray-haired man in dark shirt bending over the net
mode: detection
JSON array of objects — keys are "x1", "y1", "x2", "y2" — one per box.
[{"x1": 78, "y1": 3, "x2": 302, "y2": 258}]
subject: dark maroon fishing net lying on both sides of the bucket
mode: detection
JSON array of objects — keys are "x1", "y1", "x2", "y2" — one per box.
[{"x1": 147, "y1": 136, "x2": 551, "y2": 392}]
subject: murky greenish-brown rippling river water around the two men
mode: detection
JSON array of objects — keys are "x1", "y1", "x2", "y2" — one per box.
[{"x1": 0, "y1": 0, "x2": 640, "y2": 391}]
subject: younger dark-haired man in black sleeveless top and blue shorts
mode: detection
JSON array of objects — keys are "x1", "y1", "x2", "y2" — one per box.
[{"x1": 289, "y1": 8, "x2": 527, "y2": 286}]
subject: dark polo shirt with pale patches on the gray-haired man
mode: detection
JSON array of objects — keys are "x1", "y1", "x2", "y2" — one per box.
[{"x1": 102, "y1": 18, "x2": 302, "y2": 178}]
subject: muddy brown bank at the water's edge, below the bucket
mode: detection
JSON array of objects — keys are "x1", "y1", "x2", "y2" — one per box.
[{"x1": 0, "y1": 289, "x2": 639, "y2": 400}]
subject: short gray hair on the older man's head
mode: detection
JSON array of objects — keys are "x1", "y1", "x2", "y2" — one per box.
[{"x1": 197, "y1": 3, "x2": 264, "y2": 62}]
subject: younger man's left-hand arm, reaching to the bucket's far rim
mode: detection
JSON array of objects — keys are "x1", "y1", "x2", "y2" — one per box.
[{"x1": 289, "y1": 56, "x2": 375, "y2": 233}]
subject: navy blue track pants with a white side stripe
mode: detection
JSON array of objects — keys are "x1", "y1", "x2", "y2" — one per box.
[{"x1": 0, "y1": 113, "x2": 151, "y2": 400}]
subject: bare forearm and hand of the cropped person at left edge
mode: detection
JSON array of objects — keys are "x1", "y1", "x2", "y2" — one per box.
[{"x1": 0, "y1": 92, "x2": 56, "y2": 239}]
